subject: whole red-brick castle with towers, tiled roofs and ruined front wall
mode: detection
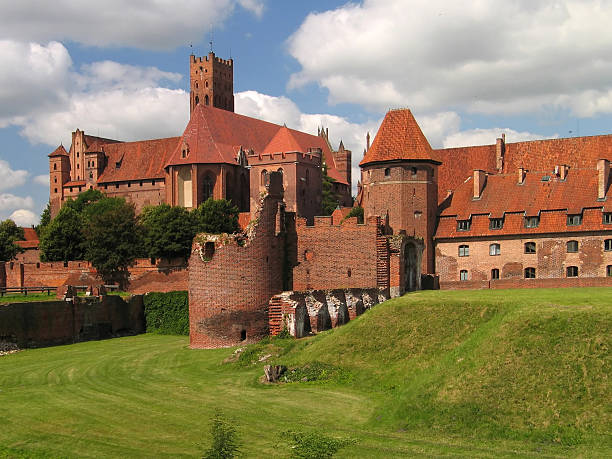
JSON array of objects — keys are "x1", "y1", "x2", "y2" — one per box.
[{"x1": 11, "y1": 48, "x2": 612, "y2": 347}]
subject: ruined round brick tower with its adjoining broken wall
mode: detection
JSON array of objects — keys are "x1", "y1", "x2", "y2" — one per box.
[{"x1": 189, "y1": 172, "x2": 423, "y2": 348}]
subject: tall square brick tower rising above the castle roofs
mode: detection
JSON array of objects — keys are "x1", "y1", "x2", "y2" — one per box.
[{"x1": 189, "y1": 51, "x2": 234, "y2": 113}]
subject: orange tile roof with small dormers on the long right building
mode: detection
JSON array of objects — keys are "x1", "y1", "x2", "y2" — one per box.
[{"x1": 436, "y1": 168, "x2": 612, "y2": 238}]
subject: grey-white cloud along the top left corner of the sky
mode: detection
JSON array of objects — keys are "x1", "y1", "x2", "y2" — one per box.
[{"x1": 0, "y1": 0, "x2": 264, "y2": 50}]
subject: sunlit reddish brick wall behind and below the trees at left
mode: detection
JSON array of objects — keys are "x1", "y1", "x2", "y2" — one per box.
[{"x1": 0, "y1": 258, "x2": 187, "y2": 293}]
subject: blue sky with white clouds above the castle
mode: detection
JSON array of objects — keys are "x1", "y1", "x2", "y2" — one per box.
[{"x1": 0, "y1": 0, "x2": 612, "y2": 225}]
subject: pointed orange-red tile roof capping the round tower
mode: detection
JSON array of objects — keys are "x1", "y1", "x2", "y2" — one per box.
[{"x1": 359, "y1": 109, "x2": 438, "y2": 166}]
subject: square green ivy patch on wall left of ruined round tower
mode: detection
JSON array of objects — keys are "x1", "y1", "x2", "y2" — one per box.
[{"x1": 144, "y1": 291, "x2": 189, "y2": 335}]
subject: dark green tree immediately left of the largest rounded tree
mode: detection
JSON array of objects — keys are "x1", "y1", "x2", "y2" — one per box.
[{"x1": 39, "y1": 206, "x2": 83, "y2": 261}]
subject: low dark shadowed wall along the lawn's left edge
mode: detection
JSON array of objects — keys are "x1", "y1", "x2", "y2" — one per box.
[{"x1": 0, "y1": 295, "x2": 145, "y2": 348}]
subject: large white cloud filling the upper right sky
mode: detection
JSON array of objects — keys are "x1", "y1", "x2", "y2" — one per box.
[{"x1": 288, "y1": 0, "x2": 612, "y2": 116}]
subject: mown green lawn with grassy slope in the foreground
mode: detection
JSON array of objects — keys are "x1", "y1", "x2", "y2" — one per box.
[{"x1": 0, "y1": 288, "x2": 612, "y2": 458}]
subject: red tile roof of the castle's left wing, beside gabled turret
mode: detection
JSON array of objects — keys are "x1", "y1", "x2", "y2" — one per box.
[{"x1": 98, "y1": 137, "x2": 180, "y2": 183}]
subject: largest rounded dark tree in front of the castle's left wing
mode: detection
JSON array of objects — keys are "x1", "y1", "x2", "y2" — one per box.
[{"x1": 83, "y1": 198, "x2": 142, "y2": 287}]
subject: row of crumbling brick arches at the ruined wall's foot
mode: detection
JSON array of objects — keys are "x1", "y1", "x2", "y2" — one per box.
[{"x1": 269, "y1": 288, "x2": 389, "y2": 338}]
